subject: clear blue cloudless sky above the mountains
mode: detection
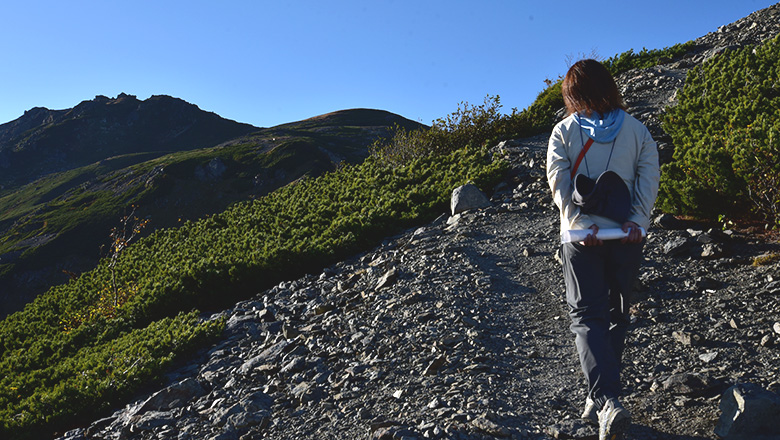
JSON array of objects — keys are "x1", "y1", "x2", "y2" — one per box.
[{"x1": 0, "y1": 0, "x2": 775, "y2": 127}]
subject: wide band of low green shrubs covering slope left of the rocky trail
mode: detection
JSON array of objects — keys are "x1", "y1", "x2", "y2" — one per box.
[{"x1": 0, "y1": 39, "x2": 756, "y2": 438}]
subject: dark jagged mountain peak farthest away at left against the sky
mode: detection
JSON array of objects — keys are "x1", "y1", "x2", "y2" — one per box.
[{"x1": 0, "y1": 93, "x2": 258, "y2": 188}]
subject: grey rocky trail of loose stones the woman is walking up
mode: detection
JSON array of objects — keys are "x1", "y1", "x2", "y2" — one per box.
[{"x1": 60, "y1": 5, "x2": 780, "y2": 440}]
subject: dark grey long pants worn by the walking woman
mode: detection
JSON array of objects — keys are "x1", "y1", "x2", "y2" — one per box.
[{"x1": 561, "y1": 240, "x2": 644, "y2": 405}]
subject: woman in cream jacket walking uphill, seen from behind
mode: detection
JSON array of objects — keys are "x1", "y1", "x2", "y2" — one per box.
[{"x1": 547, "y1": 60, "x2": 660, "y2": 438}]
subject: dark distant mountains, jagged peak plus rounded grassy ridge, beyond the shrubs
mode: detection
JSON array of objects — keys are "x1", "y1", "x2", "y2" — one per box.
[{"x1": 0, "y1": 105, "x2": 422, "y2": 316}]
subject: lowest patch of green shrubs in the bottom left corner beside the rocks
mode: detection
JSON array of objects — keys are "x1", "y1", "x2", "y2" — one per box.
[{"x1": 0, "y1": 313, "x2": 224, "y2": 439}]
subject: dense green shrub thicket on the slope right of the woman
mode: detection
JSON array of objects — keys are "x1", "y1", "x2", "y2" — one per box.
[{"x1": 659, "y1": 33, "x2": 780, "y2": 224}]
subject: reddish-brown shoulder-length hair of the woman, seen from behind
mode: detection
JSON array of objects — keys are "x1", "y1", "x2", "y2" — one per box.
[{"x1": 561, "y1": 60, "x2": 626, "y2": 115}]
